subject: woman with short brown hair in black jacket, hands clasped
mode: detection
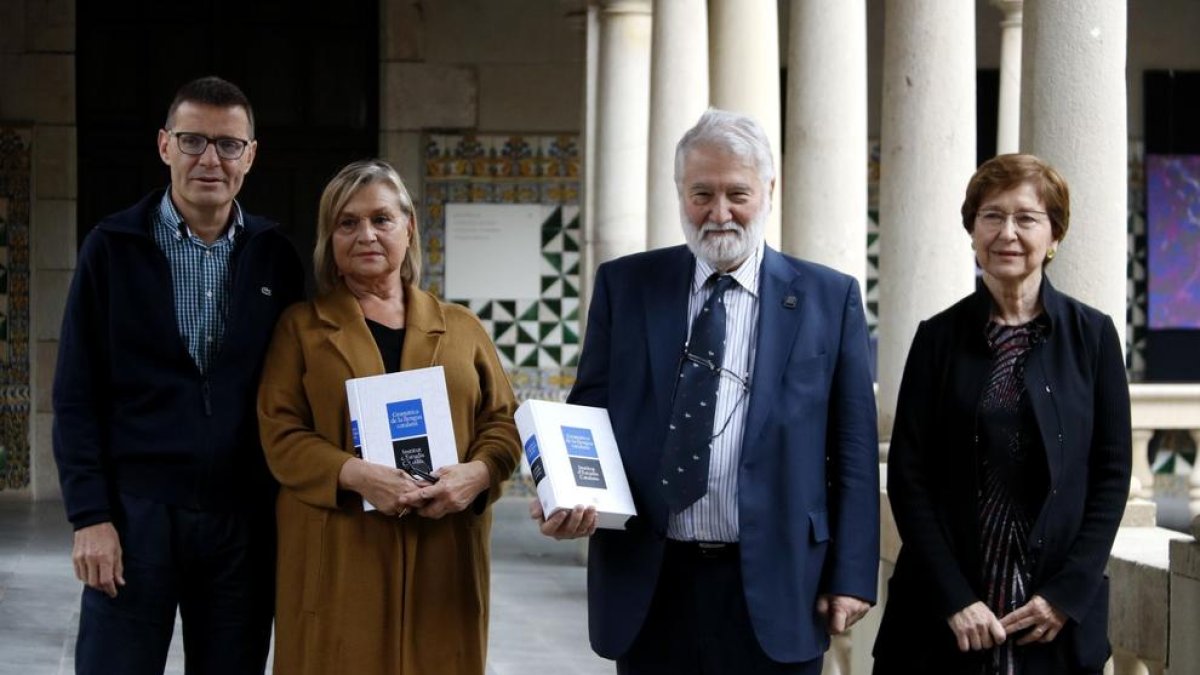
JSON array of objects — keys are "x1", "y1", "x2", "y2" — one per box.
[{"x1": 875, "y1": 155, "x2": 1132, "y2": 675}]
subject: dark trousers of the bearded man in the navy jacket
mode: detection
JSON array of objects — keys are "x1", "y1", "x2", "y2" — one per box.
[{"x1": 617, "y1": 542, "x2": 822, "y2": 675}]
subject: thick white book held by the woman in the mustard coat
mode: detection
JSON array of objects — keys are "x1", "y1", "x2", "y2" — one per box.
[{"x1": 346, "y1": 365, "x2": 458, "y2": 510}]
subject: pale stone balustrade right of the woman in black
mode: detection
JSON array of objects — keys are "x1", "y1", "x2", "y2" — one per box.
[{"x1": 1129, "y1": 384, "x2": 1200, "y2": 518}]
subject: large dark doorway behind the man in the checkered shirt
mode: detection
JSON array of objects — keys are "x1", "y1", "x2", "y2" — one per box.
[{"x1": 76, "y1": 0, "x2": 379, "y2": 285}]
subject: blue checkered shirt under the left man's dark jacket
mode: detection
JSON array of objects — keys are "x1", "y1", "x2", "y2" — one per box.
[{"x1": 150, "y1": 189, "x2": 245, "y2": 372}]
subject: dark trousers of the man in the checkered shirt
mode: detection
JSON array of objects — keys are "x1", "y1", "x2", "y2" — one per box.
[{"x1": 76, "y1": 487, "x2": 275, "y2": 675}]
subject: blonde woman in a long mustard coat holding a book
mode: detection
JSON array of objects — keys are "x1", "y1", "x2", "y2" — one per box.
[{"x1": 258, "y1": 160, "x2": 520, "y2": 675}]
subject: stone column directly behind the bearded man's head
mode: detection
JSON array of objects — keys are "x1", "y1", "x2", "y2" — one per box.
[{"x1": 708, "y1": 0, "x2": 782, "y2": 249}]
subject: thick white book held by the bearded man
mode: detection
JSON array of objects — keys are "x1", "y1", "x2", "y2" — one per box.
[{"x1": 516, "y1": 401, "x2": 637, "y2": 530}]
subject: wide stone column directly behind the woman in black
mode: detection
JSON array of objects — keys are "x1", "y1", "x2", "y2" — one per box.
[{"x1": 1021, "y1": 0, "x2": 1129, "y2": 346}]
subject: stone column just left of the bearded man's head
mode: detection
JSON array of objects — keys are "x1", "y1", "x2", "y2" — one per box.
[{"x1": 646, "y1": 0, "x2": 708, "y2": 249}]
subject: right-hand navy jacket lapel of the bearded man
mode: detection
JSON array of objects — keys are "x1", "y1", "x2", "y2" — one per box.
[{"x1": 742, "y1": 246, "x2": 804, "y2": 456}]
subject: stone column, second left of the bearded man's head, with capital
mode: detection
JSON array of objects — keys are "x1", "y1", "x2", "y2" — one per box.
[{"x1": 589, "y1": 0, "x2": 650, "y2": 269}]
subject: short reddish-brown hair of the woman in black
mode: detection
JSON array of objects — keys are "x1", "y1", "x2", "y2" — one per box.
[{"x1": 962, "y1": 154, "x2": 1070, "y2": 241}]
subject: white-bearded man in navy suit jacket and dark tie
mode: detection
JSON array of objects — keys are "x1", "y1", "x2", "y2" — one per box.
[{"x1": 540, "y1": 109, "x2": 880, "y2": 675}]
